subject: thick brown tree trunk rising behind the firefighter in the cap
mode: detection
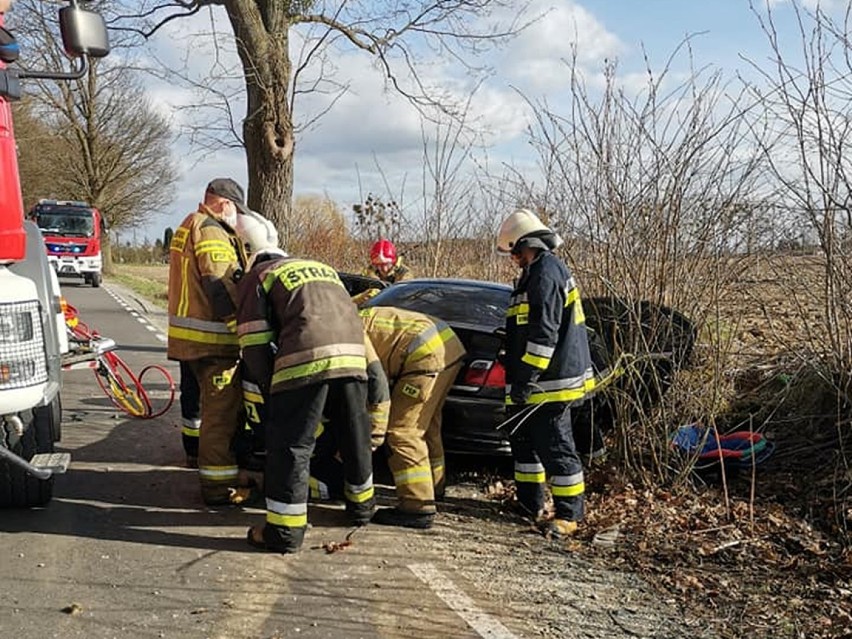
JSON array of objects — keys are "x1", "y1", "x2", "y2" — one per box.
[{"x1": 226, "y1": 0, "x2": 295, "y2": 246}]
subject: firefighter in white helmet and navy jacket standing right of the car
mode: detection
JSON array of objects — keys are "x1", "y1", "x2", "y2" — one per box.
[{"x1": 497, "y1": 209, "x2": 595, "y2": 538}]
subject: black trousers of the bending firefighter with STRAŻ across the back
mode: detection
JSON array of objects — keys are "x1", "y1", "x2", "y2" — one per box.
[{"x1": 264, "y1": 378, "x2": 375, "y2": 550}]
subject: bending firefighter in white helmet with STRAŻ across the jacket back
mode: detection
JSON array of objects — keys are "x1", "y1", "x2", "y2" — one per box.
[{"x1": 236, "y1": 217, "x2": 375, "y2": 553}]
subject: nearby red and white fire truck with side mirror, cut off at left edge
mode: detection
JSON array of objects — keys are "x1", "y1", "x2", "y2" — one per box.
[{"x1": 0, "y1": 0, "x2": 109, "y2": 507}]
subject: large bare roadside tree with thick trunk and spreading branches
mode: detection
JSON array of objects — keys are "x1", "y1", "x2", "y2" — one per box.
[{"x1": 110, "y1": 0, "x2": 527, "y2": 240}]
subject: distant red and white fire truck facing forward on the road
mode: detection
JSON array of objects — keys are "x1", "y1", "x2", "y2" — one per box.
[{"x1": 27, "y1": 200, "x2": 106, "y2": 287}]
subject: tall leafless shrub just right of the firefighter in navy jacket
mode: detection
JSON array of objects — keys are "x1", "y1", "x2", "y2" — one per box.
[{"x1": 515, "y1": 40, "x2": 769, "y2": 481}]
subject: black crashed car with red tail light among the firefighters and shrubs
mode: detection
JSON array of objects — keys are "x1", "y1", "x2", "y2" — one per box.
[{"x1": 362, "y1": 279, "x2": 695, "y2": 455}]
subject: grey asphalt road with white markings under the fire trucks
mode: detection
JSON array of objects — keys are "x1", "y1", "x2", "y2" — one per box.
[{"x1": 0, "y1": 280, "x2": 522, "y2": 639}]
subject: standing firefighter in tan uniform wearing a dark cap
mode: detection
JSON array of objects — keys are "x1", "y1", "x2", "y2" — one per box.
[{"x1": 168, "y1": 178, "x2": 252, "y2": 505}]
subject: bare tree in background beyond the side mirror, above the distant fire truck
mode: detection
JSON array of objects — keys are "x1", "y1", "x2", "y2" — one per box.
[{"x1": 5, "y1": 0, "x2": 177, "y2": 235}]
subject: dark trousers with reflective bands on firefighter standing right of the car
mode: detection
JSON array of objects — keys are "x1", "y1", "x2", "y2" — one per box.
[{"x1": 509, "y1": 402, "x2": 585, "y2": 521}]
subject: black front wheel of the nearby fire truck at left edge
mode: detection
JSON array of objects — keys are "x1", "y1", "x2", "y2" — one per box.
[{"x1": 0, "y1": 405, "x2": 54, "y2": 508}]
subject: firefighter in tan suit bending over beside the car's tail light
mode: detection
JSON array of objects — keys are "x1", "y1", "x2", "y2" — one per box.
[{"x1": 361, "y1": 306, "x2": 465, "y2": 528}]
